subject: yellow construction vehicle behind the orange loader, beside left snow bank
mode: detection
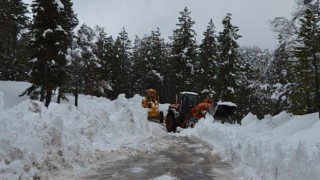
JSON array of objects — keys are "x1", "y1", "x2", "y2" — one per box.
[{"x1": 141, "y1": 89, "x2": 163, "y2": 123}]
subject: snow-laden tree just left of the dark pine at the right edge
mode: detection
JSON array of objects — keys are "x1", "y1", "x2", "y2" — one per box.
[{"x1": 266, "y1": 9, "x2": 304, "y2": 114}]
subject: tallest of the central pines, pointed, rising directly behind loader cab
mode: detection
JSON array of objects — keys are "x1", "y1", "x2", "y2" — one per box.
[{"x1": 168, "y1": 7, "x2": 197, "y2": 98}]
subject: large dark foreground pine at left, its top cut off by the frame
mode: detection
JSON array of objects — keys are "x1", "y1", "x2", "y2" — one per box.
[{"x1": 26, "y1": 0, "x2": 77, "y2": 107}]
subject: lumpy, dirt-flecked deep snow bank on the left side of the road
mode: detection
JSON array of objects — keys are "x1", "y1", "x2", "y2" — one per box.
[{"x1": 0, "y1": 87, "x2": 159, "y2": 179}]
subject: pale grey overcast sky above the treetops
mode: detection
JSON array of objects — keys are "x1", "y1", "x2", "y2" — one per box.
[{"x1": 25, "y1": 0, "x2": 294, "y2": 49}]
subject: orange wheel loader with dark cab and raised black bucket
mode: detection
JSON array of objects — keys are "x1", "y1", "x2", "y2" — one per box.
[{"x1": 165, "y1": 92, "x2": 237, "y2": 132}]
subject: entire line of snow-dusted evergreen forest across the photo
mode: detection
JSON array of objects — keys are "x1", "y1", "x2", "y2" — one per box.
[{"x1": 0, "y1": 0, "x2": 320, "y2": 119}]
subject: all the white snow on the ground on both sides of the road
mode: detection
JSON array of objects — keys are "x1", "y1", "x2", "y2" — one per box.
[{"x1": 0, "y1": 81, "x2": 320, "y2": 180}]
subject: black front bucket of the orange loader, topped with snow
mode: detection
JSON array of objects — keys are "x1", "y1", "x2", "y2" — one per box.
[{"x1": 211, "y1": 102, "x2": 237, "y2": 124}]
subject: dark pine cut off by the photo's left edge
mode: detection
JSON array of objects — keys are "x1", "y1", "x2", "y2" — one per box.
[{"x1": 0, "y1": 0, "x2": 29, "y2": 80}]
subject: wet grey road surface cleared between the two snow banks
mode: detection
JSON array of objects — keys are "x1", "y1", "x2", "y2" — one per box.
[{"x1": 81, "y1": 136, "x2": 240, "y2": 180}]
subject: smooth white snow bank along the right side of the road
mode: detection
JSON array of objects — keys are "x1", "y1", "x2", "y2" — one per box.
[{"x1": 181, "y1": 112, "x2": 320, "y2": 180}]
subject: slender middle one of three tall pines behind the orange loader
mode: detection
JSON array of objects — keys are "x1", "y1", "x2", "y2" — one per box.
[{"x1": 196, "y1": 19, "x2": 218, "y2": 98}]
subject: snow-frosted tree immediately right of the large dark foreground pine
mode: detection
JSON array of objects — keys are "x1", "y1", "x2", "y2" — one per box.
[{"x1": 66, "y1": 24, "x2": 110, "y2": 106}]
